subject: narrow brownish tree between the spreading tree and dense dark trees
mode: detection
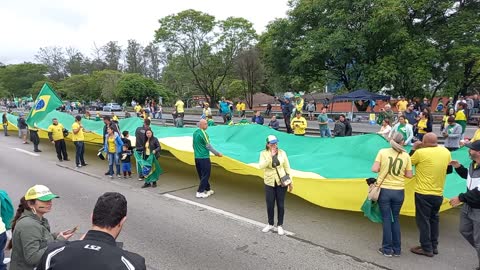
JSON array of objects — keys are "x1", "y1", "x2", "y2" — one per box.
[{"x1": 235, "y1": 48, "x2": 263, "y2": 109}]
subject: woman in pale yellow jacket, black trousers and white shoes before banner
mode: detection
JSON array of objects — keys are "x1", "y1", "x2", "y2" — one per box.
[{"x1": 258, "y1": 135, "x2": 293, "y2": 235}]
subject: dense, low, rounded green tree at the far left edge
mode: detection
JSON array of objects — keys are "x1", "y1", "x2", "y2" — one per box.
[{"x1": 0, "y1": 63, "x2": 48, "y2": 97}]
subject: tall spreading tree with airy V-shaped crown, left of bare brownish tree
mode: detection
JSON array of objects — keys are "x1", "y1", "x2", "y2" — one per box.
[{"x1": 155, "y1": 10, "x2": 256, "y2": 102}]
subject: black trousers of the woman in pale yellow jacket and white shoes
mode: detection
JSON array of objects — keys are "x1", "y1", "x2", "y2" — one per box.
[{"x1": 265, "y1": 183, "x2": 287, "y2": 226}]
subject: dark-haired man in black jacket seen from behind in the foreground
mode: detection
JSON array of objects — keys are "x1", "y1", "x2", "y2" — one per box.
[{"x1": 37, "y1": 192, "x2": 147, "y2": 270}]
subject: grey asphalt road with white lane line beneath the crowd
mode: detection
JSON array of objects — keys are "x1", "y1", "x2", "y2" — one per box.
[{"x1": 0, "y1": 134, "x2": 477, "y2": 269}]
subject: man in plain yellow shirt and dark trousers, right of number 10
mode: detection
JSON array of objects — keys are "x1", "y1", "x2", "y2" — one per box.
[{"x1": 410, "y1": 132, "x2": 452, "y2": 257}]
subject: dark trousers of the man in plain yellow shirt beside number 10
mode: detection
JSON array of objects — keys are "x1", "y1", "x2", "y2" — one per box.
[{"x1": 415, "y1": 193, "x2": 443, "y2": 253}]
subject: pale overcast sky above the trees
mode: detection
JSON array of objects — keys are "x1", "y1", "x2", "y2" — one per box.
[{"x1": 0, "y1": 0, "x2": 287, "y2": 64}]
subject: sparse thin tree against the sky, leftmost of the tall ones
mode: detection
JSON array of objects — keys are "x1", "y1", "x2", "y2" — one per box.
[{"x1": 35, "y1": 47, "x2": 67, "y2": 81}]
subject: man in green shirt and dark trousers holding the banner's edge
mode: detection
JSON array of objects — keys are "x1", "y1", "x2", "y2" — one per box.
[{"x1": 193, "y1": 119, "x2": 223, "y2": 198}]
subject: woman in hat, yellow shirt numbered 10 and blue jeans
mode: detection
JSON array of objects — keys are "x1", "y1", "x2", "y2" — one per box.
[{"x1": 372, "y1": 132, "x2": 412, "y2": 257}]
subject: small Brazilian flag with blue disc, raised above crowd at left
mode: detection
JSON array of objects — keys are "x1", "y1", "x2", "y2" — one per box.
[{"x1": 27, "y1": 83, "x2": 63, "y2": 126}]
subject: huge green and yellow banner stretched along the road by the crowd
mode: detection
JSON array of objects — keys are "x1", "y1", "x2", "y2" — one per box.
[{"x1": 0, "y1": 111, "x2": 471, "y2": 216}]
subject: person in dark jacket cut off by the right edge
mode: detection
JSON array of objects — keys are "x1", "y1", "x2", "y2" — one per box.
[{"x1": 450, "y1": 141, "x2": 480, "y2": 270}]
